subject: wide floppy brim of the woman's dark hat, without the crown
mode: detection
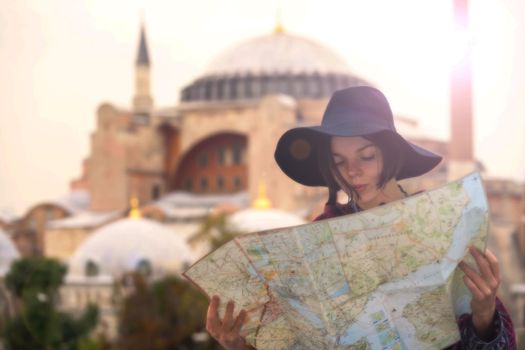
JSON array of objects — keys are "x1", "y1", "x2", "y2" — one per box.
[{"x1": 274, "y1": 125, "x2": 442, "y2": 186}]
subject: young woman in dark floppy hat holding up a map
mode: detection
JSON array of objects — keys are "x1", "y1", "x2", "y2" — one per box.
[{"x1": 206, "y1": 86, "x2": 516, "y2": 350}]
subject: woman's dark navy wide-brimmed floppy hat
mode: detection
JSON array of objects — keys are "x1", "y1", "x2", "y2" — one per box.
[{"x1": 275, "y1": 86, "x2": 441, "y2": 186}]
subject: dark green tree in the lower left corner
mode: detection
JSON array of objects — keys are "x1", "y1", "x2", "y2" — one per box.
[{"x1": 1, "y1": 257, "x2": 98, "y2": 350}]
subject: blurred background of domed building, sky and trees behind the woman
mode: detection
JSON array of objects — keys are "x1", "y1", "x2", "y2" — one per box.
[{"x1": 0, "y1": 0, "x2": 525, "y2": 349}]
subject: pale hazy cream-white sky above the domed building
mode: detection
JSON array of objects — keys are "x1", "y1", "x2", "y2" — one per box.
[{"x1": 0, "y1": 0, "x2": 525, "y2": 215}]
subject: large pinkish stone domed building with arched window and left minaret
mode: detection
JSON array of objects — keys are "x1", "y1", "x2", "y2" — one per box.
[{"x1": 72, "y1": 23, "x2": 367, "y2": 216}]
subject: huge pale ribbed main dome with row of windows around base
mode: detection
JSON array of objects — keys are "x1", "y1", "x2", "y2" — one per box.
[{"x1": 181, "y1": 33, "x2": 366, "y2": 102}]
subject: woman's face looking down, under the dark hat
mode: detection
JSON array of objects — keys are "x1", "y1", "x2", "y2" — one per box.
[{"x1": 331, "y1": 136, "x2": 383, "y2": 207}]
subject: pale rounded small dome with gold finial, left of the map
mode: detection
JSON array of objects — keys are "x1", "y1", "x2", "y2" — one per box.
[{"x1": 69, "y1": 218, "x2": 192, "y2": 277}]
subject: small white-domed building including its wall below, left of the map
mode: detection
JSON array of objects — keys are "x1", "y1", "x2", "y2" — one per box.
[{"x1": 61, "y1": 218, "x2": 195, "y2": 337}]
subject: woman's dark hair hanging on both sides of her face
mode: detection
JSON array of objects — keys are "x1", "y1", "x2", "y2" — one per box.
[{"x1": 316, "y1": 132, "x2": 404, "y2": 205}]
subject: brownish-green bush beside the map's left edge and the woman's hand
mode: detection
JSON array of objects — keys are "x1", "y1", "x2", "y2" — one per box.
[{"x1": 117, "y1": 274, "x2": 220, "y2": 350}]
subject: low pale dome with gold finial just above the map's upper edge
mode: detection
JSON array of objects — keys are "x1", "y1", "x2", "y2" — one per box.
[{"x1": 229, "y1": 208, "x2": 306, "y2": 233}]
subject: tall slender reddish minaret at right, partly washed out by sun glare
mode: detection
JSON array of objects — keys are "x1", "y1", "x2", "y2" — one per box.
[{"x1": 448, "y1": 0, "x2": 476, "y2": 180}]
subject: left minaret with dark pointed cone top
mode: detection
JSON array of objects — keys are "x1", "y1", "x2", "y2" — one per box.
[{"x1": 133, "y1": 24, "x2": 153, "y2": 115}]
